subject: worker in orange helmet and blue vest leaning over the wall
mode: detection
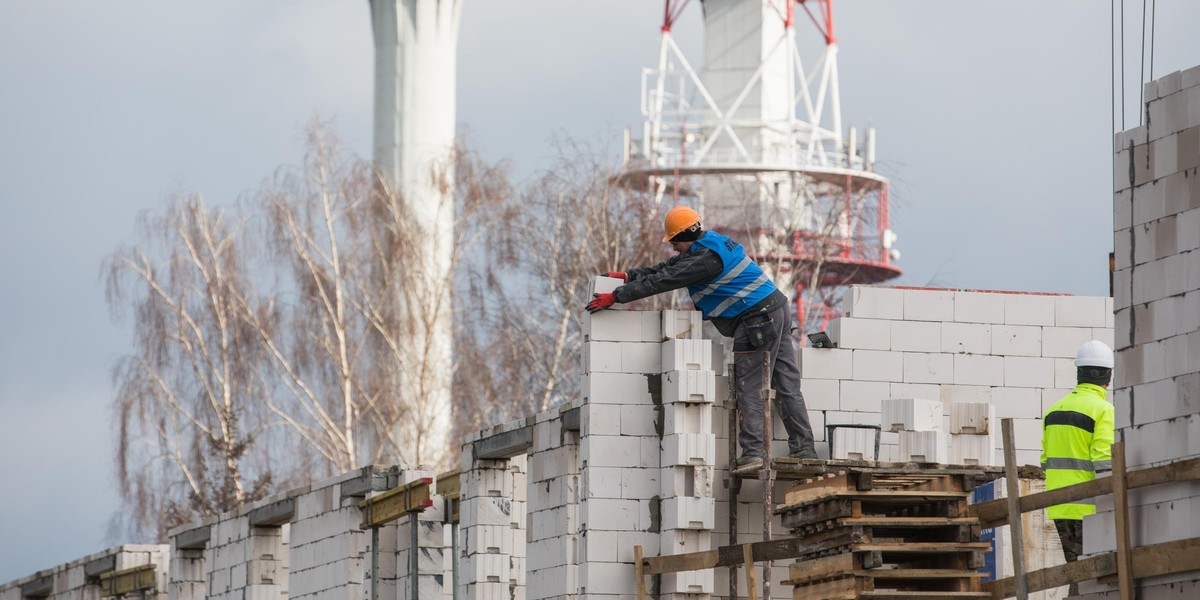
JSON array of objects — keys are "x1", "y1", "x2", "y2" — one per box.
[{"x1": 587, "y1": 206, "x2": 817, "y2": 470}]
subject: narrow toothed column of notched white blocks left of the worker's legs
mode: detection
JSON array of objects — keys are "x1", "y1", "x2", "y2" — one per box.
[{"x1": 659, "y1": 311, "x2": 720, "y2": 599}]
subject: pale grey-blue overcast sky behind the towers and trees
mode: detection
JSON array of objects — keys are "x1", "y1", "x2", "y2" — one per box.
[{"x1": 0, "y1": 0, "x2": 1200, "y2": 582}]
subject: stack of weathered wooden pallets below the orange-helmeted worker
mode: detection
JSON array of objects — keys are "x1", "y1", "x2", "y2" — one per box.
[{"x1": 778, "y1": 467, "x2": 995, "y2": 600}]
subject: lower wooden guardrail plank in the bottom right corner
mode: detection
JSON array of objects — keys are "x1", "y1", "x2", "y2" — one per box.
[{"x1": 983, "y1": 538, "x2": 1200, "y2": 600}]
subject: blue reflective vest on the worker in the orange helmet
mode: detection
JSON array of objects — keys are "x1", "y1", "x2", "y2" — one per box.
[{"x1": 688, "y1": 232, "x2": 775, "y2": 319}]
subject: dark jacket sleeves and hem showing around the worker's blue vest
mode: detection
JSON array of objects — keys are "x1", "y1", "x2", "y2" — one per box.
[{"x1": 613, "y1": 244, "x2": 787, "y2": 337}]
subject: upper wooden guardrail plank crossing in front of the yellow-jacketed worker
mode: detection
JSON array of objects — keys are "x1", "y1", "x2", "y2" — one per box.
[{"x1": 970, "y1": 458, "x2": 1200, "y2": 529}]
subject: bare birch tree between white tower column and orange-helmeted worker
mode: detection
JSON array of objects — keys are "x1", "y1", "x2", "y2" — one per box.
[{"x1": 455, "y1": 142, "x2": 671, "y2": 441}]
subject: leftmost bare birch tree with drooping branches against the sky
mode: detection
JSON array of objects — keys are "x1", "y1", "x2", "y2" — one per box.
[{"x1": 106, "y1": 196, "x2": 280, "y2": 539}]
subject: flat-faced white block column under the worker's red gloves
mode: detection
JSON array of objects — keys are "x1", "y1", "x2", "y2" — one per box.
[{"x1": 578, "y1": 277, "x2": 674, "y2": 598}]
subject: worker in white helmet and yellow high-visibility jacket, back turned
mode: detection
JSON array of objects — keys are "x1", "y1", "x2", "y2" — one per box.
[{"x1": 1042, "y1": 340, "x2": 1115, "y2": 595}]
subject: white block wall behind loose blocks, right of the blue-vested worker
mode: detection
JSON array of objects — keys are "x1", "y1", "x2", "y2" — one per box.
[{"x1": 800, "y1": 286, "x2": 1112, "y2": 464}]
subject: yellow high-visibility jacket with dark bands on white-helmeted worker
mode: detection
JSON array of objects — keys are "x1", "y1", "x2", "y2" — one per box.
[{"x1": 1042, "y1": 383, "x2": 1116, "y2": 521}]
